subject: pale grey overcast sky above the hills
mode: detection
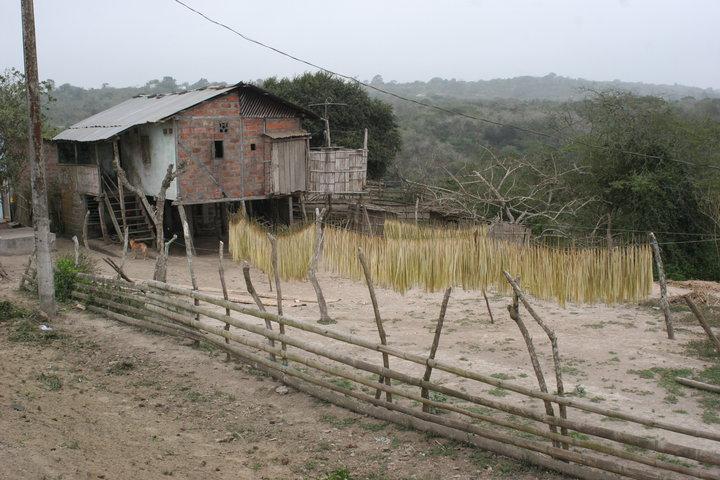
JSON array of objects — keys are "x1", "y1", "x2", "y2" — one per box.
[{"x1": 0, "y1": 0, "x2": 720, "y2": 88}]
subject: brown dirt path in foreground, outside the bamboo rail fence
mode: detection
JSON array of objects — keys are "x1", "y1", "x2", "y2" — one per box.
[{"x1": 0, "y1": 291, "x2": 559, "y2": 480}]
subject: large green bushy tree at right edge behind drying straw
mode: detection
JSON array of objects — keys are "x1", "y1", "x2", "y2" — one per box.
[{"x1": 568, "y1": 92, "x2": 720, "y2": 278}]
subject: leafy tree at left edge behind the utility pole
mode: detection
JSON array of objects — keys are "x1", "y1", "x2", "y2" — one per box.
[{"x1": 0, "y1": 68, "x2": 54, "y2": 189}]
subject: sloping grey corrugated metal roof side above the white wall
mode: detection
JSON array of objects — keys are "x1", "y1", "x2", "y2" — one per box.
[{"x1": 53, "y1": 85, "x2": 235, "y2": 142}]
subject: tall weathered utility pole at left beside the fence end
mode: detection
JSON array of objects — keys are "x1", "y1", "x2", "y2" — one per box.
[{"x1": 20, "y1": 0, "x2": 55, "y2": 317}]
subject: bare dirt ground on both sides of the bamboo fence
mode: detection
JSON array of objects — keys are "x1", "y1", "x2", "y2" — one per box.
[{"x1": 0, "y1": 239, "x2": 720, "y2": 480}]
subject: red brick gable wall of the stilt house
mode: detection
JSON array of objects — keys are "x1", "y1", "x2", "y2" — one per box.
[{"x1": 177, "y1": 92, "x2": 300, "y2": 202}]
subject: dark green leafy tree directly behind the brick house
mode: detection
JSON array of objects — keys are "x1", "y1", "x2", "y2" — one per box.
[{"x1": 263, "y1": 72, "x2": 401, "y2": 178}]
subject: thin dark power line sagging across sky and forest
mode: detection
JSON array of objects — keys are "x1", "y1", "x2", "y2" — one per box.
[{"x1": 172, "y1": 0, "x2": 720, "y2": 170}]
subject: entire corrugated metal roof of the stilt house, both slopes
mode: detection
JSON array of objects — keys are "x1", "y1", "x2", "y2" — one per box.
[{"x1": 53, "y1": 83, "x2": 318, "y2": 142}]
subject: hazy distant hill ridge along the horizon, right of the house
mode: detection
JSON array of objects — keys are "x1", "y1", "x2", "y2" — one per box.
[{"x1": 370, "y1": 73, "x2": 720, "y2": 102}]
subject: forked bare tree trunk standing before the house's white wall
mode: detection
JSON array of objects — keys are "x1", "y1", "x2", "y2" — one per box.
[{"x1": 113, "y1": 142, "x2": 183, "y2": 282}]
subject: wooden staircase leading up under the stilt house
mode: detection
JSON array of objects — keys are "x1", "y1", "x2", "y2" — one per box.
[{"x1": 103, "y1": 176, "x2": 155, "y2": 244}]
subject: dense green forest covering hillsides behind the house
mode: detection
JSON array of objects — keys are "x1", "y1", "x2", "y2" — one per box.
[{"x1": 5, "y1": 73, "x2": 720, "y2": 279}]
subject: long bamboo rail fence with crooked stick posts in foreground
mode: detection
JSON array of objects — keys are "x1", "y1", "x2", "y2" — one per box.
[{"x1": 67, "y1": 274, "x2": 720, "y2": 480}]
